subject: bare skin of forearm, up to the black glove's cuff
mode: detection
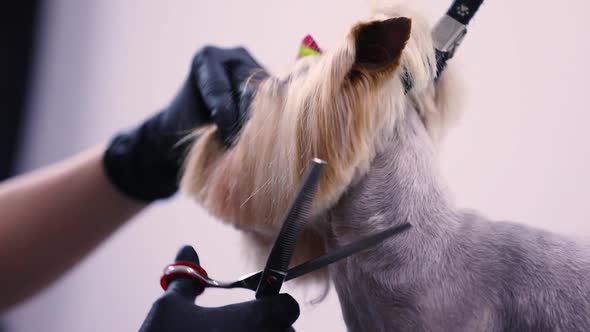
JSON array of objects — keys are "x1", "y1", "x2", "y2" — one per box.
[{"x1": 0, "y1": 147, "x2": 146, "y2": 311}]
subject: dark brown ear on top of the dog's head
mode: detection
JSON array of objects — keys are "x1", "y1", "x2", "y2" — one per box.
[{"x1": 352, "y1": 17, "x2": 412, "y2": 70}]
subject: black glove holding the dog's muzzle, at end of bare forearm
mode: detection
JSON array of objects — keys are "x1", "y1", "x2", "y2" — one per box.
[{"x1": 104, "y1": 47, "x2": 266, "y2": 202}]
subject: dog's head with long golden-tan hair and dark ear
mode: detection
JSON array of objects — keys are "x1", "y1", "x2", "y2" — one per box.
[{"x1": 182, "y1": 8, "x2": 460, "y2": 280}]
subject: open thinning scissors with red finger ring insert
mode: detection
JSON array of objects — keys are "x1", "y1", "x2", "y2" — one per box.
[{"x1": 160, "y1": 158, "x2": 411, "y2": 298}]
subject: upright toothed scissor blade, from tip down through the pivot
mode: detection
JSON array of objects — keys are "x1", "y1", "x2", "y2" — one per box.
[{"x1": 256, "y1": 159, "x2": 325, "y2": 298}]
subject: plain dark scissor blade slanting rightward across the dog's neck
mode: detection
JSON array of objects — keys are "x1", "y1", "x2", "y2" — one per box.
[{"x1": 285, "y1": 224, "x2": 412, "y2": 281}]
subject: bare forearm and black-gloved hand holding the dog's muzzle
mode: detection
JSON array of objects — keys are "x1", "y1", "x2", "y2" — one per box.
[{"x1": 0, "y1": 47, "x2": 260, "y2": 311}]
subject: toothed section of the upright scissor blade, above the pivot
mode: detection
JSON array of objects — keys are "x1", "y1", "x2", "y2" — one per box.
[{"x1": 266, "y1": 158, "x2": 326, "y2": 271}]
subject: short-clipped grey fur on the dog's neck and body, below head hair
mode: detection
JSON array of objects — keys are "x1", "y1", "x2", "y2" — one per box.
[{"x1": 326, "y1": 110, "x2": 590, "y2": 331}]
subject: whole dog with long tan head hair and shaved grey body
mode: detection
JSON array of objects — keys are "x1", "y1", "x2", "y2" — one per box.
[{"x1": 182, "y1": 8, "x2": 590, "y2": 331}]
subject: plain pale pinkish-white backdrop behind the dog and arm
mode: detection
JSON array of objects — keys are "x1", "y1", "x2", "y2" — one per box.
[{"x1": 5, "y1": 0, "x2": 590, "y2": 332}]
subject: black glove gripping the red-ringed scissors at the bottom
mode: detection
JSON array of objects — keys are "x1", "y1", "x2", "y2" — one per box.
[{"x1": 140, "y1": 246, "x2": 299, "y2": 332}]
